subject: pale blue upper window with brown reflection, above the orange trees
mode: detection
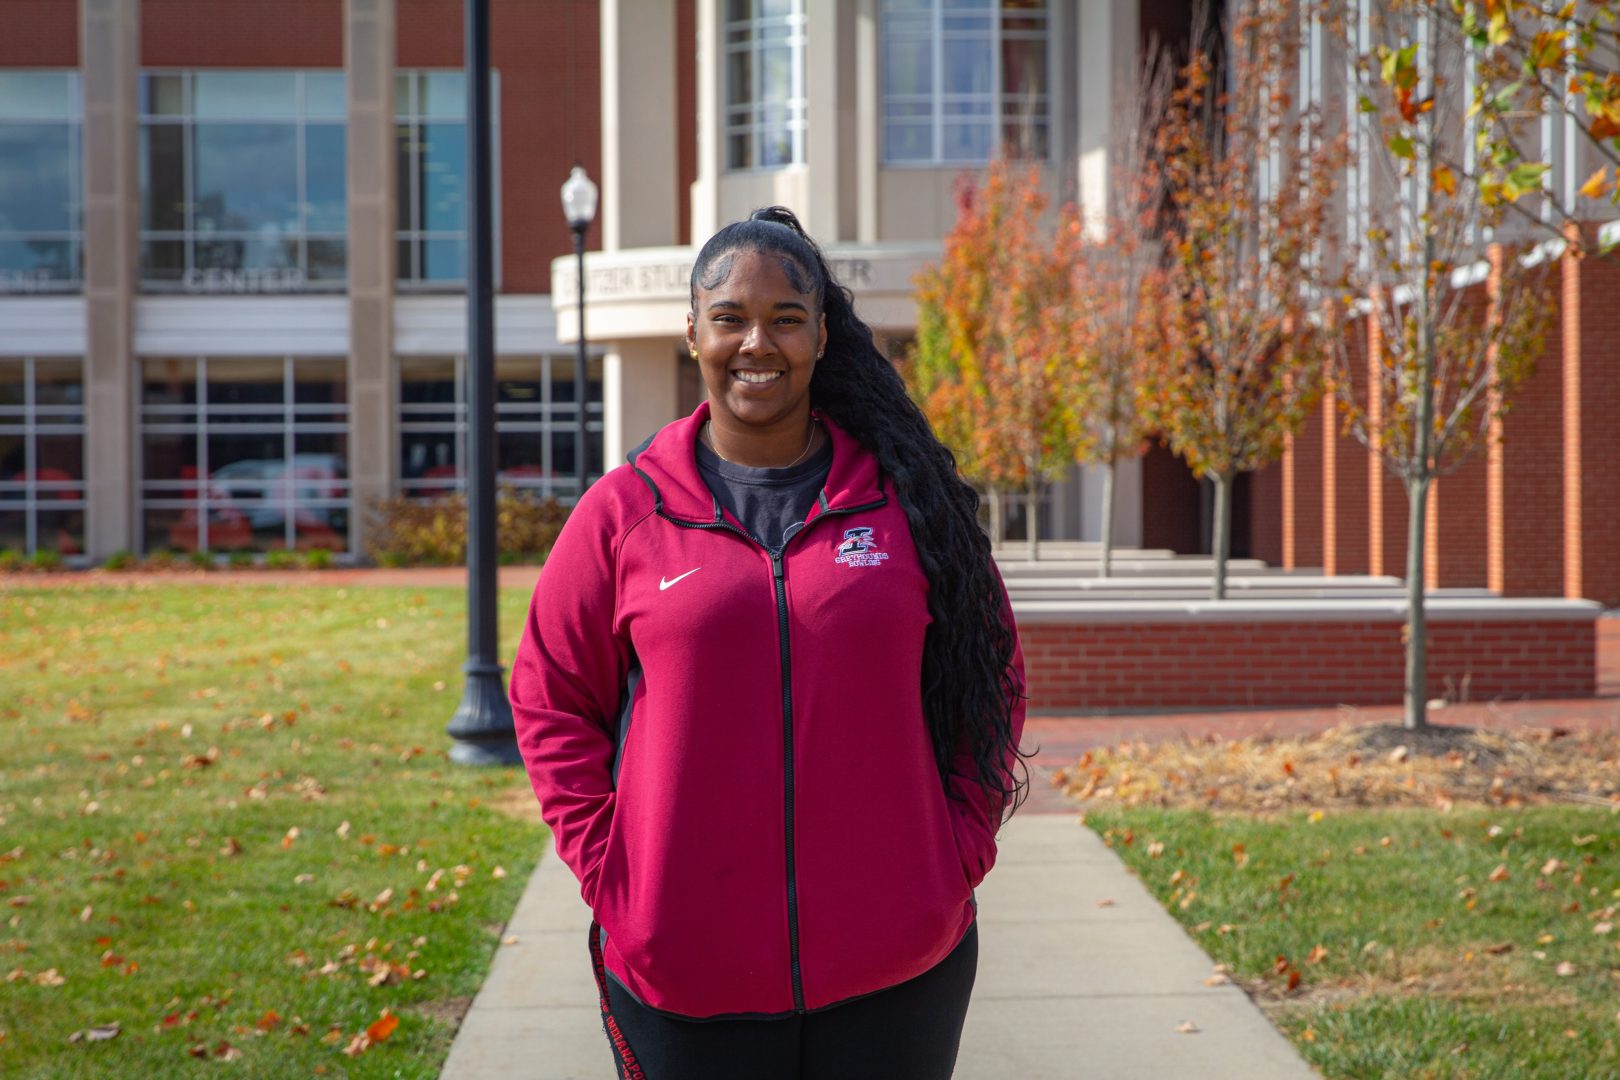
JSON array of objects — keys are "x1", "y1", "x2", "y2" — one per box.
[{"x1": 880, "y1": 0, "x2": 1051, "y2": 165}]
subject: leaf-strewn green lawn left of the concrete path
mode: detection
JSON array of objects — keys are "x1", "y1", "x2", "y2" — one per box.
[{"x1": 0, "y1": 585, "x2": 550, "y2": 1078}]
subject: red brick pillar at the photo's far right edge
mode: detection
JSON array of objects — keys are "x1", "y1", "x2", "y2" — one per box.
[{"x1": 1563, "y1": 234, "x2": 1620, "y2": 607}]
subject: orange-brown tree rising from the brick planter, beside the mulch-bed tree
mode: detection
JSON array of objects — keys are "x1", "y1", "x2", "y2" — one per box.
[{"x1": 1153, "y1": 0, "x2": 1343, "y2": 599}]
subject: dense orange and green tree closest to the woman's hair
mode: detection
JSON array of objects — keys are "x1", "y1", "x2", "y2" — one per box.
[{"x1": 906, "y1": 160, "x2": 1081, "y2": 559}]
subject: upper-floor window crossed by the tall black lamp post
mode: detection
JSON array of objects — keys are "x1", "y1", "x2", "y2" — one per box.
[{"x1": 394, "y1": 71, "x2": 501, "y2": 288}]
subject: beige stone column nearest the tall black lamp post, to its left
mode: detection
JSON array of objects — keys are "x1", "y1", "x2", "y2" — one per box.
[{"x1": 343, "y1": 0, "x2": 399, "y2": 554}]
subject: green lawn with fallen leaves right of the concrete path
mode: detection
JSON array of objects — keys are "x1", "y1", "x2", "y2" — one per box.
[{"x1": 1087, "y1": 806, "x2": 1620, "y2": 1080}]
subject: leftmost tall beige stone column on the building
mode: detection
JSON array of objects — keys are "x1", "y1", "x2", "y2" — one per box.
[{"x1": 79, "y1": 0, "x2": 141, "y2": 559}]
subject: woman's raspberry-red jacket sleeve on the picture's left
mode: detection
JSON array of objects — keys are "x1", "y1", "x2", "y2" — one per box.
[{"x1": 510, "y1": 483, "x2": 629, "y2": 904}]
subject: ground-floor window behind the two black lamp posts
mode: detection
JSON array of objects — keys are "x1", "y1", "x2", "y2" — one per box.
[{"x1": 400, "y1": 356, "x2": 603, "y2": 499}]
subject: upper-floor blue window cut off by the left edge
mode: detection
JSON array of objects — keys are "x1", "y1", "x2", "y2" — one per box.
[{"x1": 0, "y1": 71, "x2": 83, "y2": 293}]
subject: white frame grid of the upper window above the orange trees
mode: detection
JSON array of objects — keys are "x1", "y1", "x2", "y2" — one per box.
[{"x1": 876, "y1": 0, "x2": 1058, "y2": 170}]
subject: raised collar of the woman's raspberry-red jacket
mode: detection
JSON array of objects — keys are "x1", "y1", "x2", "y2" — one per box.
[{"x1": 629, "y1": 402, "x2": 885, "y2": 525}]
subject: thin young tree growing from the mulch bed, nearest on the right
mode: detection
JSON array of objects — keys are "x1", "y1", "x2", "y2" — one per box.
[{"x1": 1333, "y1": 0, "x2": 1552, "y2": 729}]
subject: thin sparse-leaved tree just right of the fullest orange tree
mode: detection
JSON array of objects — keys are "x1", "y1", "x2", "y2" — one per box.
[{"x1": 1059, "y1": 44, "x2": 1175, "y2": 578}]
